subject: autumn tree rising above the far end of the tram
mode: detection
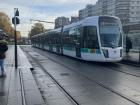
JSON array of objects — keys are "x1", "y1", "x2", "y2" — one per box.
[{"x1": 30, "y1": 23, "x2": 44, "y2": 36}]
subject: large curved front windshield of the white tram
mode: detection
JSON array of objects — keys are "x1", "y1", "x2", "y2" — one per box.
[{"x1": 99, "y1": 17, "x2": 122, "y2": 48}]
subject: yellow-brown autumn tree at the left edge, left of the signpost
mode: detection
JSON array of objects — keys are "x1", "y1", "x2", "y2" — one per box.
[{"x1": 0, "y1": 12, "x2": 13, "y2": 35}]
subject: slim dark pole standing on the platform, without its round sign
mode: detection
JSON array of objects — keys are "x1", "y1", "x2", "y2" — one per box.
[{"x1": 14, "y1": 8, "x2": 18, "y2": 69}]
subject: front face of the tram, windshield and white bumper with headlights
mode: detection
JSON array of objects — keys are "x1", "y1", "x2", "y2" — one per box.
[{"x1": 99, "y1": 16, "x2": 123, "y2": 62}]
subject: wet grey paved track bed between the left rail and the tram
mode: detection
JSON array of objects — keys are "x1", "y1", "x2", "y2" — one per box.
[{"x1": 21, "y1": 46, "x2": 140, "y2": 105}]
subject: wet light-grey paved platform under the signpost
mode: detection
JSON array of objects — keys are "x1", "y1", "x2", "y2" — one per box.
[{"x1": 0, "y1": 46, "x2": 46, "y2": 105}]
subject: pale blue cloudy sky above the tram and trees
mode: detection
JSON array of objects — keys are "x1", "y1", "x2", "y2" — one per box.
[{"x1": 0, "y1": 0, "x2": 97, "y2": 37}]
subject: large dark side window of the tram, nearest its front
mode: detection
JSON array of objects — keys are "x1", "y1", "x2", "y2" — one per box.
[{"x1": 84, "y1": 26, "x2": 99, "y2": 48}]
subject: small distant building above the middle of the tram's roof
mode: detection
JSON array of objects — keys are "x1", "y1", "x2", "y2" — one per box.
[{"x1": 54, "y1": 16, "x2": 70, "y2": 28}]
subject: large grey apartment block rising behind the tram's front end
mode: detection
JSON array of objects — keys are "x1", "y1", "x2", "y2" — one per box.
[{"x1": 79, "y1": 0, "x2": 140, "y2": 25}]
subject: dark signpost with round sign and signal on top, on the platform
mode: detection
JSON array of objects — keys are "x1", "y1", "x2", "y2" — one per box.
[{"x1": 12, "y1": 8, "x2": 19, "y2": 69}]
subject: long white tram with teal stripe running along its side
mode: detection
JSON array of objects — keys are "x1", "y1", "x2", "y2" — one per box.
[{"x1": 31, "y1": 16, "x2": 123, "y2": 62}]
